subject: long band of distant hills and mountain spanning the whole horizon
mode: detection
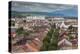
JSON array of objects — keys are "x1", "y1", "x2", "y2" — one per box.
[{"x1": 11, "y1": 10, "x2": 77, "y2": 17}]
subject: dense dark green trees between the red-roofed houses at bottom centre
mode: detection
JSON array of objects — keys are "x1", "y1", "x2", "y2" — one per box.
[{"x1": 40, "y1": 27, "x2": 59, "y2": 51}]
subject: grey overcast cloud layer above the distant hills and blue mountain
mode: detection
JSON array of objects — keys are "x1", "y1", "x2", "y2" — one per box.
[{"x1": 12, "y1": 2, "x2": 77, "y2": 16}]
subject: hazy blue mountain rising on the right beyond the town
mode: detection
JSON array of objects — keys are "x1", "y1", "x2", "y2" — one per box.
[{"x1": 53, "y1": 9, "x2": 78, "y2": 17}]
